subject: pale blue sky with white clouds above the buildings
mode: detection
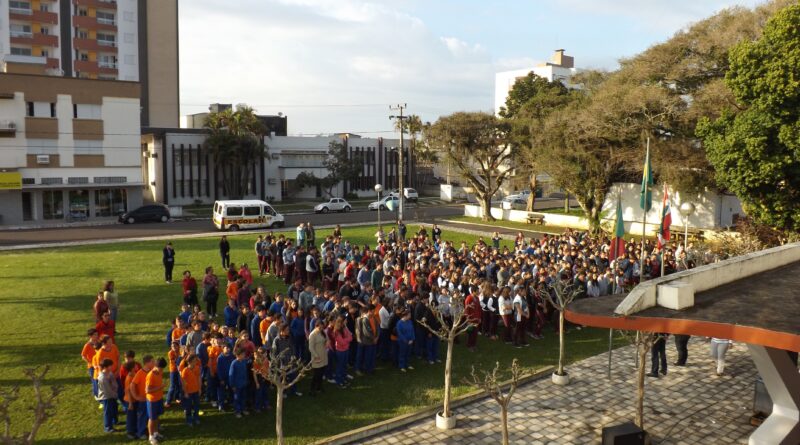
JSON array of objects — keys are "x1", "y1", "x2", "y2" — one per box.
[{"x1": 179, "y1": 0, "x2": 760, "y2": 137}]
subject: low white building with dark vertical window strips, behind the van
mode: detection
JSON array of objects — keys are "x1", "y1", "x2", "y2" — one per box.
[{"x1": 141, "y1": 128, "x2": 414, "y2": 206}]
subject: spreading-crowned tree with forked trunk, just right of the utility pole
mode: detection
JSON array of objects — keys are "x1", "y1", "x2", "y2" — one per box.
[{"x1": 426, "y1": 112, "x2": 517, "y2": 221}]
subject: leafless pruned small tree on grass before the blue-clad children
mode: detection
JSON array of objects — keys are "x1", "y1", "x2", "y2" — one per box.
[{"x1": 253, "y1": 349, "x2": 311, "y2": 445}]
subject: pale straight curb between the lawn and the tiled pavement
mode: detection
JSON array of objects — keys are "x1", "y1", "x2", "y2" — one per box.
[{"x1": 313, "y1": 366, "x2": 555, "y2": 445}]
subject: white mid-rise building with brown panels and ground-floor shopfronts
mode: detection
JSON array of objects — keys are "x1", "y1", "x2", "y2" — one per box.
[{"x1": 0, "y1": 73, "x2": 143, "y2": 225}]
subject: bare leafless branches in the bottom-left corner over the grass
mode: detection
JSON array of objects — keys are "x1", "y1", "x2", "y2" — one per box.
[{"x1": 0, "y1": 365, "x2": 63, "y2": 445}]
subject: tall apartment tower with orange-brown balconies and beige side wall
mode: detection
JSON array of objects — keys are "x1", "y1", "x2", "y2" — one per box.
[{"x1": 0, "y1": 0, "x2": 179, "y2": 127}]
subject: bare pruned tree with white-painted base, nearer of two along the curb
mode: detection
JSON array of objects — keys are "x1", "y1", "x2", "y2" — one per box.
[{"x1": 419, "y1": 292, "x2": 477, "y2": 417}]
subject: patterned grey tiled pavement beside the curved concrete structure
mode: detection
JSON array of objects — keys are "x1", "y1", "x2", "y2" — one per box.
[{"x1": 359, "y1": 337, "x2": 757, "y2": 445}]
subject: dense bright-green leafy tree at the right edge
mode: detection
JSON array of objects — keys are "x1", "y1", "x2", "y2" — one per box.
[{"x1": 697, "y1": 4, "x2": 800, "y2": 232}]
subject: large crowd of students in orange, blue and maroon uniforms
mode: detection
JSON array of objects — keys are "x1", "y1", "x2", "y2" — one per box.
[{"x1": 82, "y1": 221, "x2": 689, "y2": 444}]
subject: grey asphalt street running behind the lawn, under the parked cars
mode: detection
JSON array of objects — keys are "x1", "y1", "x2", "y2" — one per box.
[{"x1": 0, "y1": 206, "x2": 464, "y2": 246}]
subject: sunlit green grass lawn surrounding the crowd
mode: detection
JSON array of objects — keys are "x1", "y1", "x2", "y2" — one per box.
[{"x1": 0, "y1": 226, "x2": 620, "y2": 444}]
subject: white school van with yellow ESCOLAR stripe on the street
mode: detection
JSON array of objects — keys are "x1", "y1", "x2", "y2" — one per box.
[{"x1": 214, "y1": 200, "x2": 286, "y2": 232}]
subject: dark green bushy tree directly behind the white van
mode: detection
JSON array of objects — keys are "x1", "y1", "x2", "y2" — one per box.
[{"x1": 205, "y1": 104, "x2": 267, "y2": 199}]
